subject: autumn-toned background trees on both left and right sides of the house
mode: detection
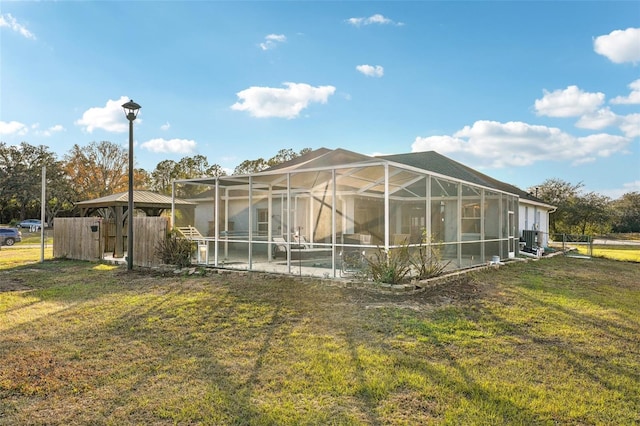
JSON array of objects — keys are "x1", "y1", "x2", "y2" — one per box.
[{"x1": 0, "y1": 141, "x2": 640, "y2": 235}]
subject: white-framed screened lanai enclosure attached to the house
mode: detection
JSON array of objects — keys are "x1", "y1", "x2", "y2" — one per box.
[{"x1": 173, "y1": 149, "x2": 518, "y2": 278}]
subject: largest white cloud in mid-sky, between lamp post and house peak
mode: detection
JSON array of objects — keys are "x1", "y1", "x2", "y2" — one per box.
[{"x1": 231, "y1": 82, "x2": 336, "y2": 119}]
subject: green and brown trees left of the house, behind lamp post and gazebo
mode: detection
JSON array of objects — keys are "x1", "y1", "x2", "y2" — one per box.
[{"x1": 0, "y1": 141, "x2": 310, "y2": 224}]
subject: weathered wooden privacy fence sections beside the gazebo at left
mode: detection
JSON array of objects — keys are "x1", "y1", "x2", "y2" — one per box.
[{"x1": 53, "y1": 217, "x2": 169, "y2": 267}]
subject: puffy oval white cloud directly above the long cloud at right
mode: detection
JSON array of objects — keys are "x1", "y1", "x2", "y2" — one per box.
[{"x1": 535, "y1": 86, "x2": 605, "y2": 117}]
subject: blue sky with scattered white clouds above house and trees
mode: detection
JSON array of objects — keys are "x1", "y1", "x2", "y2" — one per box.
[{"x1": 0, "y1": 1, "x2": 640, "y2": 198}]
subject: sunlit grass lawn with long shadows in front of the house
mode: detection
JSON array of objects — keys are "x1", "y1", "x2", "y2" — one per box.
[{"x1": 0, "y1": 249, "x2": 640, "y2": 425}]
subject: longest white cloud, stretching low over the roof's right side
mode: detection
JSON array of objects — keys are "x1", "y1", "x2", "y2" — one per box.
[{"x1": 411, "y1": 120, "x2": 630, "y2": 168}]
